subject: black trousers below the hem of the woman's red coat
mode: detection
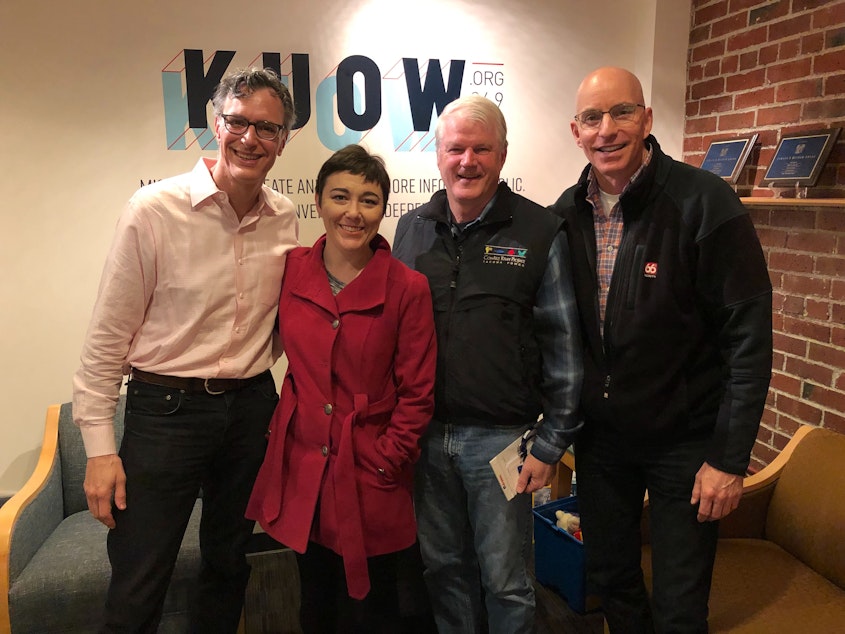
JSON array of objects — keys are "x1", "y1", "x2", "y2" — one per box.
[{"x1": 297, "y1": 542, "x2": 437, "y2": 634}]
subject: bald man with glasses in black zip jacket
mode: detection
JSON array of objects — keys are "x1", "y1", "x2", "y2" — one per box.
[{"x1": 552, "y1": 68, "x2": 772, "y2": 632}]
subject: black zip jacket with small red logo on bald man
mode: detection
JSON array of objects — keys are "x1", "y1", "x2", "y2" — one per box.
[{"x1": 551, "y1": 136, "x2": 772, "y2": 474}]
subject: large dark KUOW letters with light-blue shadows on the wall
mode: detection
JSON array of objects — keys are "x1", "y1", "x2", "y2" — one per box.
[{"x1": 161, "y1": 49, "x2": 466, "y2": 152}]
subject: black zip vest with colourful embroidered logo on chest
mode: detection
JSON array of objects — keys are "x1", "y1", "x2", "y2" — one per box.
[{"x1": 393, "y1": 183, "x2": 562, "y2": 426}]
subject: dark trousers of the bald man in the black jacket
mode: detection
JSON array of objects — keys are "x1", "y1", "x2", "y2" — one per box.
[{"x1": 575, "y1": 427, "x2": 718, "y2": 633}]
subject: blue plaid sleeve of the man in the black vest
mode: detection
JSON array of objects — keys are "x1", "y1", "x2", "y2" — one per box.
[{"x1": 531, "y1": 230, "x2": 584, "y2": 464}]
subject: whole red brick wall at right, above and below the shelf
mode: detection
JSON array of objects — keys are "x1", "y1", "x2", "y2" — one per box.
[{"x1": 684, "y1": 0, "x2": 845, "y2": 468}]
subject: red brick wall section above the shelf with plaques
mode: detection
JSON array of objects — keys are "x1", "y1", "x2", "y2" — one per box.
[{"x1": 684, "y1": 0, "x2": 845, "y2": 198}]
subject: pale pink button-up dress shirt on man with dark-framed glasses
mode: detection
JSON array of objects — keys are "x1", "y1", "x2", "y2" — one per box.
[{"x1": 73, "y1": 158, "x2": 298, "y2": 457}]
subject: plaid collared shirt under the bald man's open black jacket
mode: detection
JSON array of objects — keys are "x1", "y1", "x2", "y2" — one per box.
[{"x1": 587, "y1": 148, "x2": 652, "y2": 334}]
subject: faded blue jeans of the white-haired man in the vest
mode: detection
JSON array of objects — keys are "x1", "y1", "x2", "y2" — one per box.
[{"x1": 415, "y1": 421, "x2": 535, "y2": 634}]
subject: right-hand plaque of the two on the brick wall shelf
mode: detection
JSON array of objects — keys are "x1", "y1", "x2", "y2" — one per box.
[{"x1": 760, "y1": 128, "x2": 841, "y2": 187}]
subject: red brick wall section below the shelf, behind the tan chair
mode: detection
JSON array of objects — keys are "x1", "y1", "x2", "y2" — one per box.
[{"x1": 749, "y1": 204, "x2": 845, "y2": 466}]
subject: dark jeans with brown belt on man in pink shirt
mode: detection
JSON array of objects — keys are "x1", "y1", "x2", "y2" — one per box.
[{"x1": 103, "y1": 372, "x2": 278, "y2": 633}]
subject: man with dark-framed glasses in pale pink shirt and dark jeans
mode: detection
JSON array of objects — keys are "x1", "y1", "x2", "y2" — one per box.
[{"x1": 73, "y1": 69, "x2": 297, "y2": 632}]
